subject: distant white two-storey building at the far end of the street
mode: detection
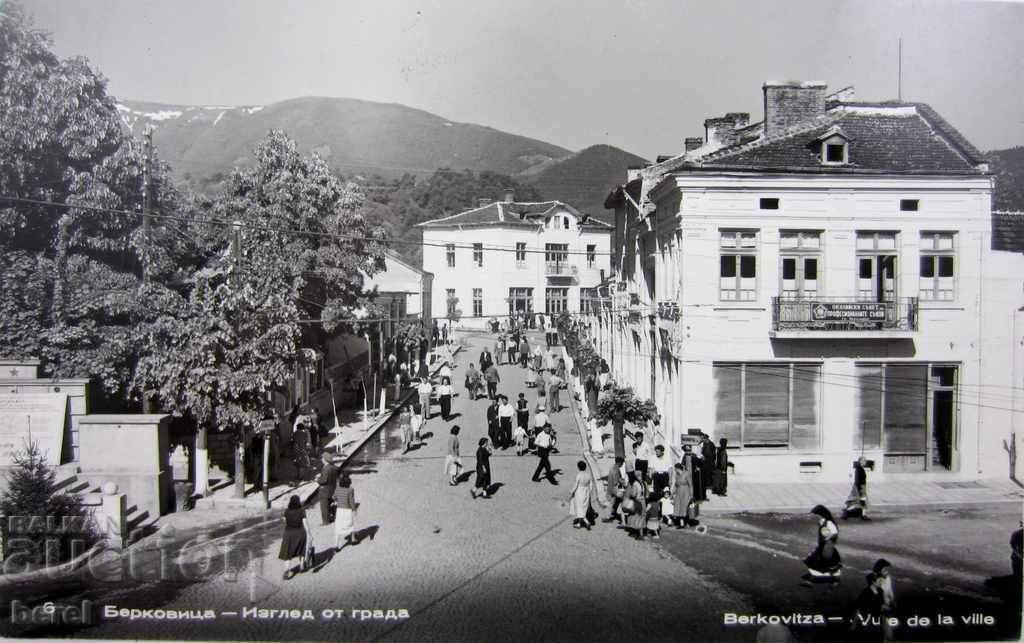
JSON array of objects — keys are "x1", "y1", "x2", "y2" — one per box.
[{"x1": 419, "y1": 192, "x2": 611, "y2": 328}]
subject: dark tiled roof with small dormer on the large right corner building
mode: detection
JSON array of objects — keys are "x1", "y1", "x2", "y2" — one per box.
[{"x1": 650, "y1": 102, "x2": 985, "y2": 174}]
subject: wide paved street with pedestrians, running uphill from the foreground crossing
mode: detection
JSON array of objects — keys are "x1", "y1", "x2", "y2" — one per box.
[{"x1": 4, "y1": 337, "x2": 1020, "y2": 641}]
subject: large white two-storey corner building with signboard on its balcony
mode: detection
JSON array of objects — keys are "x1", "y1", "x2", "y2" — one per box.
[{"x1": 591, "y1": 82, "x2": 1024, "y2": 480}]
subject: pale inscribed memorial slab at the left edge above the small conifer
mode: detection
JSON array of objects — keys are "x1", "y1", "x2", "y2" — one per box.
[{"x1": 0, "y1": 393, "x2": 68, "y2": 467}]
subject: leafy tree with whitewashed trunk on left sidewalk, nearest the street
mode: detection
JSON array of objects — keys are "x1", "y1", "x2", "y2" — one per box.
[{"x1": 134, "y1": 131, "x2": 385, "y2": 491}]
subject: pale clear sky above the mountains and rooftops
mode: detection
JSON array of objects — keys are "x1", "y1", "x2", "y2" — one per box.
[{"x1": 23, "y1": 0, "x2": 1024, "y2": 159}]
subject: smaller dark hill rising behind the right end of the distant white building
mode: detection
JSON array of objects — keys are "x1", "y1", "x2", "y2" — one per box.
[{"x1": 521, "y1": 145, "x2": 647, "y2": 222}]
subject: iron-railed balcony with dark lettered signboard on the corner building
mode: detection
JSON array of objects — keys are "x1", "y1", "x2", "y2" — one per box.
[{"x1": 769, "y1": 297, "x2": 918, "y2": 339}]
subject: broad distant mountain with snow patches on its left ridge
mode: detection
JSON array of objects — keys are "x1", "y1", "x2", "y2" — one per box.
[{"x1": 118, "y1": 97, "x2": 571, "y2": 188}]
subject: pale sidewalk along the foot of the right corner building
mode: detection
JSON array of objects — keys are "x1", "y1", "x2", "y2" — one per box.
[{"x1": 569, "y1": 387, "x2": 1024, "y2": 513}]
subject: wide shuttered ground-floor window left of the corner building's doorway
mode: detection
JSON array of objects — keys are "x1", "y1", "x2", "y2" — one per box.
[{"x1": 713, "y1": 363, "x2": 821, "y2": 449}]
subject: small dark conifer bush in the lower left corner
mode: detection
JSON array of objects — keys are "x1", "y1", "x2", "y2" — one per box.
[{"x1": 0, "y1": 441, "x2": 98, "y2": 565}]
